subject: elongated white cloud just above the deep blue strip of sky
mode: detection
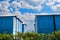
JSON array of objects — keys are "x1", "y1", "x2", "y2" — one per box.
[{"x1": 21, "y1": 2, "x2": 42, "y2": 11}]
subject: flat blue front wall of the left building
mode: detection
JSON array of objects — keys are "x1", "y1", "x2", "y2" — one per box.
[{"x1": 0, "y1": 17, "x2": 13, "y2": 34}]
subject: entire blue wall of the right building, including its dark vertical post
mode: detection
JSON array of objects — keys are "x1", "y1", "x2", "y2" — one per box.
[{"x1": 35, "y1": 15, "x2": 60, "y2": 34}]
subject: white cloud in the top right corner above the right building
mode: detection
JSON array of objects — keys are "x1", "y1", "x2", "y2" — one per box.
[{"x1": 46, "y1": 0, "x2": 60, "y2": 12}]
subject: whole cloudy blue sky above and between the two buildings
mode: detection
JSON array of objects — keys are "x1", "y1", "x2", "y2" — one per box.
[{"x1": 0, "y1": 0, "x2": 60, "y2": 31}]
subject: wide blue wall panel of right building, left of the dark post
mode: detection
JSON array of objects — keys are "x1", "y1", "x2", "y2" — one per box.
[{"x1": 36, "y1": 15, "x2": 54, "y2": 34}]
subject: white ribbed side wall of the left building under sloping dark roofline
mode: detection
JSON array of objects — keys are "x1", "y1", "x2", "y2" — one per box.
[{"x1": 13, "y1": 17, "x2": 22, "y2": 35}]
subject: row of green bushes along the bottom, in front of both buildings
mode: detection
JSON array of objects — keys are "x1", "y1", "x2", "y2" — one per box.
[{"x1": 0, "y1": 30, "x2": 60, "y2": 40}]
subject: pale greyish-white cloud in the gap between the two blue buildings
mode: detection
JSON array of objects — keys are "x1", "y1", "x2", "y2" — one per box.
[{"x1": 20, "y1": 13, "x2": 35, "y2": 31}]
